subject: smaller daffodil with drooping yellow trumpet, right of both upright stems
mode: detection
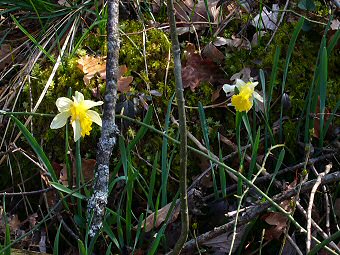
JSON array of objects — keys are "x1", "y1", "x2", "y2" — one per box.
[{"x1": 223, "y1": 79, "x2": 263, "y2": 112}]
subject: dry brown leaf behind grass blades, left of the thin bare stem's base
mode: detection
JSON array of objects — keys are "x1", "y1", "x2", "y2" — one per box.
[{"x1": 138, "y1": 203, "x2": 180, "y2": 232}]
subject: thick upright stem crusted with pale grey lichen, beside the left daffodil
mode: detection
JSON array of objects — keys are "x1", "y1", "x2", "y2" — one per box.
[{"x1": 87, "y1": 0, "x2": 119, "y2": 237}]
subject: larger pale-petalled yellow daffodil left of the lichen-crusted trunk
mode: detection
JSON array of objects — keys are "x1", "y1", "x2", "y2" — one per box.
[{"x1": 50, "y1": 91, "x2": 103, "y2": 142}]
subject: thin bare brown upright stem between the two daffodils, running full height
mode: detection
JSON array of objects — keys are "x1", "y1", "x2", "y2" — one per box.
[{"x1": 167, "y1": 0, "x2": 189, "y2": 254}]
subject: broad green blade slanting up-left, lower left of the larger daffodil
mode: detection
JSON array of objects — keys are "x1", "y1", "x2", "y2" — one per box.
[{"x1": 10, "y1": 115, "x2": 58, "y2": 182}]
